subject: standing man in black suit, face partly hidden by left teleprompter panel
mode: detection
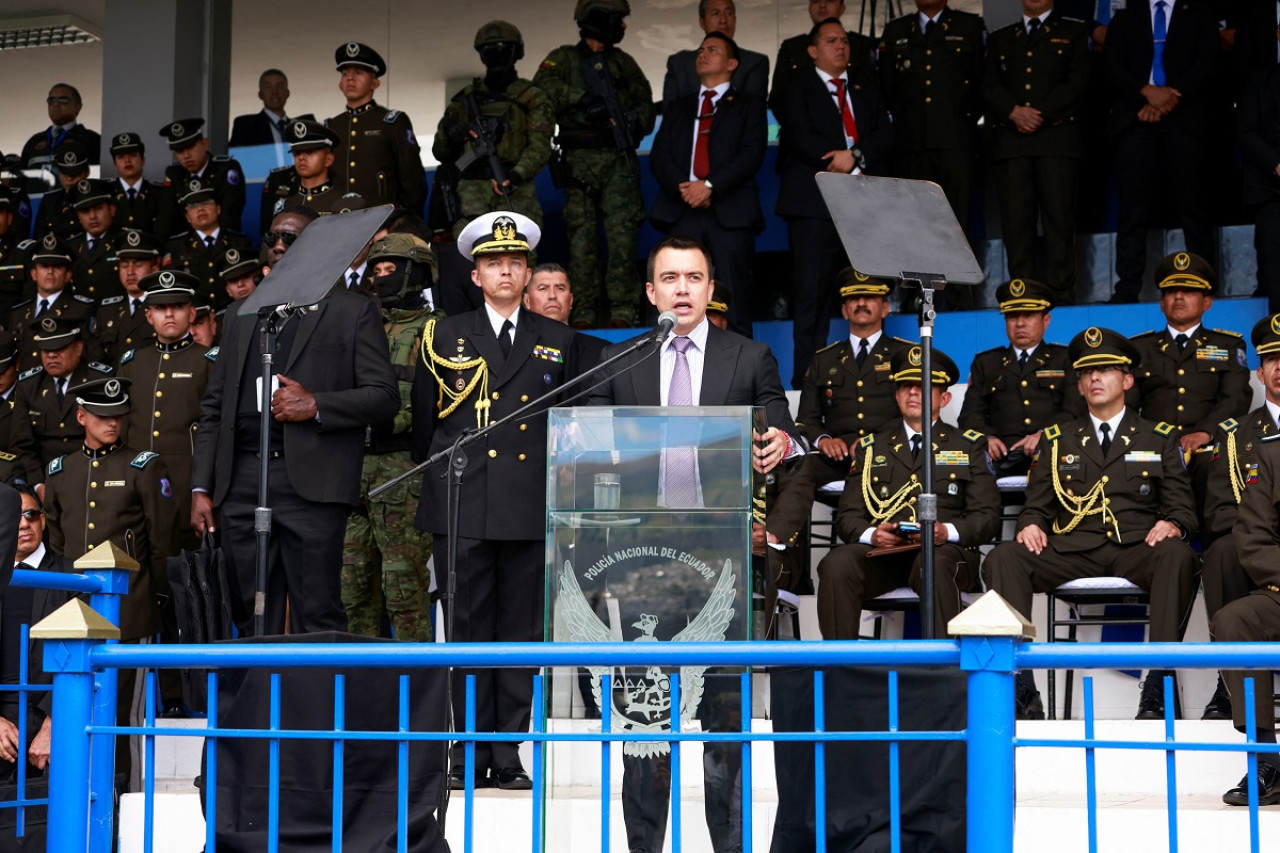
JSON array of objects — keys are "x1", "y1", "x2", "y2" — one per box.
[{"x1": 191, "y1": 207, "x2": 399, "y2": 637}]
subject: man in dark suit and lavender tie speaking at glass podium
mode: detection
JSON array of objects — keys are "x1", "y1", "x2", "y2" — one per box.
[{"x1": 588, "y1": 233, "x2": 798, "y2": 853}]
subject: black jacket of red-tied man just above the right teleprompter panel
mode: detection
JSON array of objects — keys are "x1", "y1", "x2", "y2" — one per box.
[{"x1": 776, "y1": 70, "x2": 893, "y2": 219}]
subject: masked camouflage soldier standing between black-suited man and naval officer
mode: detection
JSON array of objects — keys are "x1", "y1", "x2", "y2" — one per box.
[{"x1": 342, "y1": 234, "x2": 435, "y2": 642}]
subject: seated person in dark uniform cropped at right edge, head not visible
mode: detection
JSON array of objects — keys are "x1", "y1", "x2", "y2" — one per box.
[{"x1": 1210, "y1": 430, "x2": 1280, "y2": 806}]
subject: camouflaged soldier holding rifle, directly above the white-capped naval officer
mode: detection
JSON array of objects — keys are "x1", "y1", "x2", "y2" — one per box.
[{"x1": 431, "y1": 20, "x2": 556, "y2": 237}]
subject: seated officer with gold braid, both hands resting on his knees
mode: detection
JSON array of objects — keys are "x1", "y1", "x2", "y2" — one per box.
[{"x1": 983, "y1": 327, "x2": 1196, "y2": 720}]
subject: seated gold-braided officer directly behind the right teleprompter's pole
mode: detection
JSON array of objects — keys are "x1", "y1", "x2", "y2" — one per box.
[{"x1": 818, "y1": 346, "x2": 1000, "y2": 639}]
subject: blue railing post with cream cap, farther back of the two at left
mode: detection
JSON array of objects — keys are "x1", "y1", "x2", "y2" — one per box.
[{"x1": 76, "y1": 542, "x2": 138, "y2": 853}]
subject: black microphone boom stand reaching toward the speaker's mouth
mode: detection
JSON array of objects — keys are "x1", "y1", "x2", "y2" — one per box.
[{"x1": 371, "y1": 320, "x2": 671, "y2": 833}]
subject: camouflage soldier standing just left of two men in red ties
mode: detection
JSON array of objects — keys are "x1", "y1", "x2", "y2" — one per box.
[{"x1": 534, "y1": 0, "x2": 654, "y2": 328}]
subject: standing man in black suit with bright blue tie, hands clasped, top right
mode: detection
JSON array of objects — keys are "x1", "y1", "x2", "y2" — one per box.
[{"x1": 1105, "y1": 0, "x2": 1219, "y2": 302}]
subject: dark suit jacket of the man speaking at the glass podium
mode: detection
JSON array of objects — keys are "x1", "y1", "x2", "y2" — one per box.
[{"x1": 588, "y1": 318, "x2": 806, "y2": 446}]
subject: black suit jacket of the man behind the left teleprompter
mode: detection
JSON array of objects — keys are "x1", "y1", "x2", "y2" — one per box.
[{"x1": 191, "y1": 283, "x2": 399, "y2": 506}]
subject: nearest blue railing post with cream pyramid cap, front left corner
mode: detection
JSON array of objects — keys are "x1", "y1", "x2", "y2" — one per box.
[{"x1": 31, "y1": 599, "x2": 120, "y2": 853}]
